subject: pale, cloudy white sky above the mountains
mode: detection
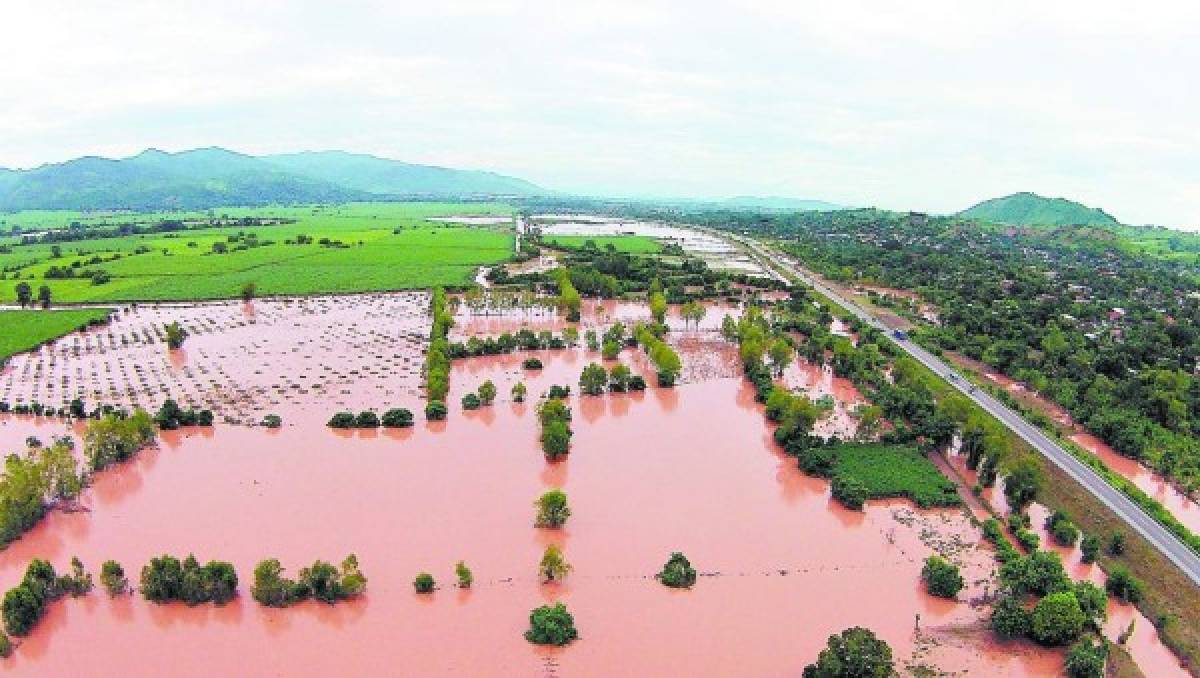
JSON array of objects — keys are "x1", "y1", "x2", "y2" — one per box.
[{"x1": 0, "y1": 0, "x2": 1200, "y2": 229}]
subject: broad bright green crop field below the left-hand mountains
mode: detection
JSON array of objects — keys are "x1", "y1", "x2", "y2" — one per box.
[{"x1": 0, "y1": 203, "x2": 514, "y2": 302}]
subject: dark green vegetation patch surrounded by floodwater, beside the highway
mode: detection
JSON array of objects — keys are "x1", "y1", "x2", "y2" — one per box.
[{"x1": 829, "y1": 444, "x2": 962, "y2": 509}]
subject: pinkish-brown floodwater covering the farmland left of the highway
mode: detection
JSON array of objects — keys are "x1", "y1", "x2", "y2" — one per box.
[{"x1": 0, "y1": 295, "x2": 1108, "y2": 677}]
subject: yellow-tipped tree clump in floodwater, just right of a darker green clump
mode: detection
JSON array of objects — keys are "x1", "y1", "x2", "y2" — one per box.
[{"x1": 250, "y1": 553, "x2": 367, "y2": 607}]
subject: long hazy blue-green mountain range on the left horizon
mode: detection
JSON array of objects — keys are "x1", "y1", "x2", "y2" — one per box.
[{"x1": 0, "y1": 148, "x2": 545, "y2": 210}]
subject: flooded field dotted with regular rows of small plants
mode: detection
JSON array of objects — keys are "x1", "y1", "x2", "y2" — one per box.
[{"x1": 0, "y1": 292, "x2": 430, "y2": 422}]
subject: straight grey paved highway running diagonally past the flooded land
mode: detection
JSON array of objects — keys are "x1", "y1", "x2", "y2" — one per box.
[{"x1": 734, "y1": 230, "x2": 1200, "y2": 586}]
